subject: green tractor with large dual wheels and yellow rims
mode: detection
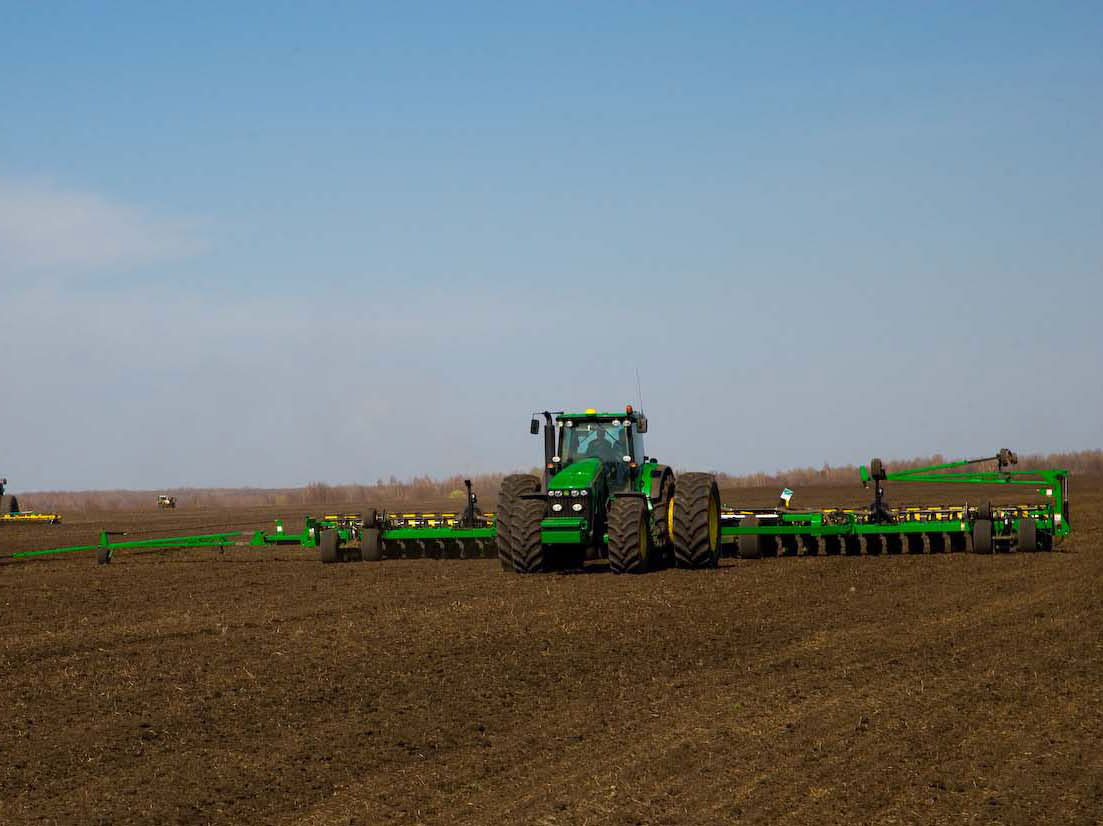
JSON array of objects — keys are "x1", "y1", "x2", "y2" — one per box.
[{"x1": 497, "y1": 406, "x2": 720, "y2": 573}]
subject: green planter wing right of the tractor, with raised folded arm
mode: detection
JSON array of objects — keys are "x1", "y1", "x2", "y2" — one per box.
[{"x1": 720, "y1": 449, "x2": 1071, "y2": 559}]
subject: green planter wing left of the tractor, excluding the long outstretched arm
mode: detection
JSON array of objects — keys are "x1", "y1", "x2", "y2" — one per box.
[{"x1": 249, "y1": 479, "x2": 495, "y2": 562}]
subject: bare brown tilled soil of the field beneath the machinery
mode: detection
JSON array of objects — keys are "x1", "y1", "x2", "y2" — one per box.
[{"x1": 0, "y1": 481, "x2": 1103, "y2": 826}]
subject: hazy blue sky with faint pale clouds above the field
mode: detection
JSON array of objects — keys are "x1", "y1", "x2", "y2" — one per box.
[{"x1": 0, "y1": 2, "x2": 1103, "y2": 491}]
